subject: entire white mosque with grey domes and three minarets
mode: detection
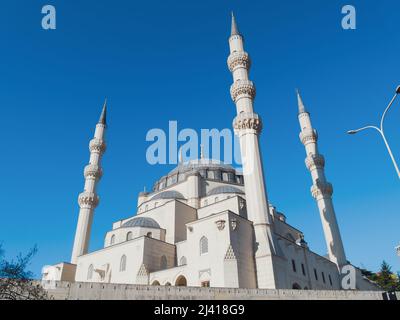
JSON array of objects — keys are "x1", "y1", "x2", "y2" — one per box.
[{"x1": 43, "y1": 16, "x2": 376, "y2": 290}]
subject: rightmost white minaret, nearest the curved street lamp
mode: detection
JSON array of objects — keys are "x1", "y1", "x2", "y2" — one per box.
[{"x1": 297, "y1": 91, "x2": 347, "y2": 267}]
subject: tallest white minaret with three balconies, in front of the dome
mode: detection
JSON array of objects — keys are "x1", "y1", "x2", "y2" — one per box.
[{"x1": 228, "y1": 14, "x2": 277, "y2": 289}]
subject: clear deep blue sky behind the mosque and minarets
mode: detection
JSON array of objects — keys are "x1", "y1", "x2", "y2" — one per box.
[{"x1": 0, "y1": 0, "x2": 400, "y2": 274}]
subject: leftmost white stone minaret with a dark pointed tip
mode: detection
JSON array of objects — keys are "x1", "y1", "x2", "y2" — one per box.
[{"x1": 71, "y1": 102, "x2": 107, "y2": 264}]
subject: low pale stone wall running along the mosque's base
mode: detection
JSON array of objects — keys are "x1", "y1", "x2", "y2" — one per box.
[{"x1": 44, "y1": 282, "x2": 388, "y2": 300}]
